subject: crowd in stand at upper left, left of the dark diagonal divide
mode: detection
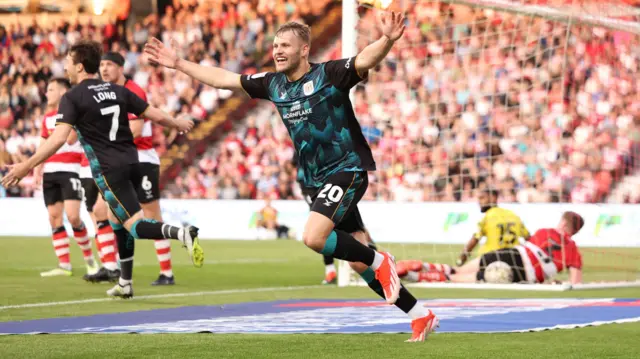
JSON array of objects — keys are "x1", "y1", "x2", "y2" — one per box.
[{"x1": 0, "y1": 0, "x2": 332, "y2": 197}]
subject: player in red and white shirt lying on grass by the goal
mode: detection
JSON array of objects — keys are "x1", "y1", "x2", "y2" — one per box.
[{"x1": 398, "y1": 212, "x2": 584, "y2": 284}]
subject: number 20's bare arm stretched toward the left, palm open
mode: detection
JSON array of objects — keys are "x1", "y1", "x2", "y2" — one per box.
[{"x1": 144, "y1": 37, "x2": 242, "y2": 90}]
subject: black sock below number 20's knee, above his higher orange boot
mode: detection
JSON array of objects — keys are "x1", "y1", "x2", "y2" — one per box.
[{"x1": 321, "y1": 229, "x2": 376, "y2": 266}]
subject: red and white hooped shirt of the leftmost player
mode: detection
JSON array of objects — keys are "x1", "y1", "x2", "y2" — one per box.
[{"x1": 40, "y1": 110, "x2": 83, "y2": 173}]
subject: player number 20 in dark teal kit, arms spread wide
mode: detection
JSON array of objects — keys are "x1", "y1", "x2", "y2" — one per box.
[{"x1": 145, "y1": 13, "x2": 438, "y2": 341}]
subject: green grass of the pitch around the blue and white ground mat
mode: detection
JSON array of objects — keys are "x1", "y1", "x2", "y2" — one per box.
[{"x1": 0, "y1": 238, "x2": 640, "y2": 359}]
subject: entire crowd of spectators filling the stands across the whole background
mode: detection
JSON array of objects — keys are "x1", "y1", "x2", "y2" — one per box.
[{"x1": 0, "y1": 0, "x2": 640, "y2": 203}]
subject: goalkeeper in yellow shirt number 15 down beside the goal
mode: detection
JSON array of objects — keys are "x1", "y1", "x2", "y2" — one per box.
[{"x1": 456, "y1": 189, "x2": 529, "y2": 274}]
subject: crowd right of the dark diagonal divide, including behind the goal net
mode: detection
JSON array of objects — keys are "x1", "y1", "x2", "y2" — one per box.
[{"x1": 170, "y1": 3, "x2": 640, "y2": 203}]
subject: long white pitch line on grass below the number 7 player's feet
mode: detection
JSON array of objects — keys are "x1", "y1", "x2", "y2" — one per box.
[{"x1": 0, "y1": 285, "x2": 324, "y2": 310}]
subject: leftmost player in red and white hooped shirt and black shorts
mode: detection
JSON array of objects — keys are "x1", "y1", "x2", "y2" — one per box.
[{"x1": 35, "y1": 79, "x2": 98, "y2": 277}]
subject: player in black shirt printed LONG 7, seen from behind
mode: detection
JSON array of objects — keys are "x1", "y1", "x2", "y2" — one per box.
[{"x1": 2, "y1": 41, "x2": 204, "y2": 298}]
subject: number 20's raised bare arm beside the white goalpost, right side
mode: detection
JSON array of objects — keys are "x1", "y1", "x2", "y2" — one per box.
[{"x1": 355, "y1": 12, "x2": 404, "y2": 77}]
